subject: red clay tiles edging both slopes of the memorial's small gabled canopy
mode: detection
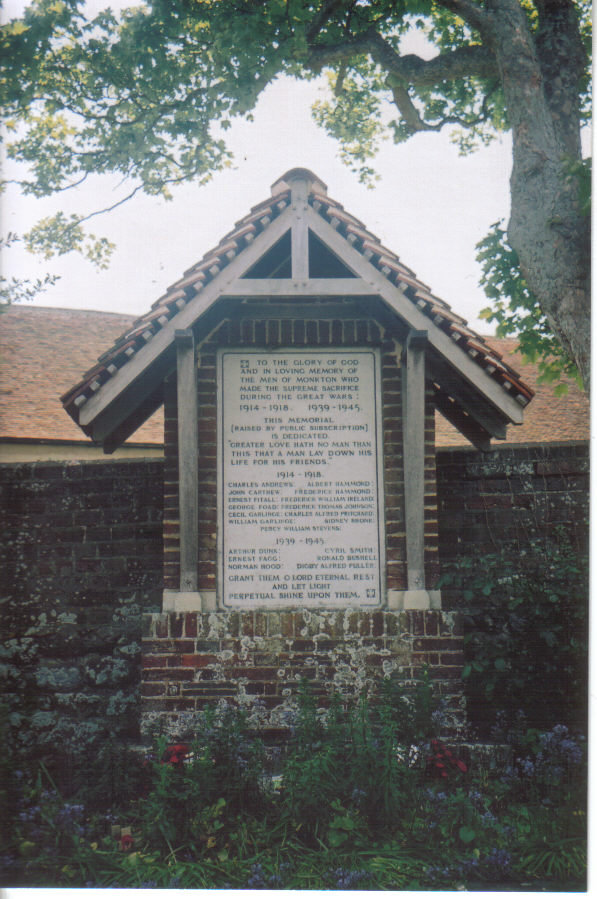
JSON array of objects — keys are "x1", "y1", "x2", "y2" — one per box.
[{"x1": 62, "y1": 170, "x2": 533, "y2": 421}]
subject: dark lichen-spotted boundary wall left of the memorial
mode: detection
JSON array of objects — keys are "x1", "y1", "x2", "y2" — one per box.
[{"x1": 0, "y1": 460, "x2": 162, "y2": 760}]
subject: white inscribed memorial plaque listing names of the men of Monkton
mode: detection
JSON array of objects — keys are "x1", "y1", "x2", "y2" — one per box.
[{"x1": 218, "y1": 349, "x2": 384, "y2": 608}]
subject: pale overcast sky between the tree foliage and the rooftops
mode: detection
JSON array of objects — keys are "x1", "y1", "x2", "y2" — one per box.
[{"x1": 2, "y1": 0, "x2": 511, "y2": 333}]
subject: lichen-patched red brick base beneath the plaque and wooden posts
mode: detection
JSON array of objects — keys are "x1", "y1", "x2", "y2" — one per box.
[{"x1": 141, "y1": 609, "x2": 464, "y2": 738}]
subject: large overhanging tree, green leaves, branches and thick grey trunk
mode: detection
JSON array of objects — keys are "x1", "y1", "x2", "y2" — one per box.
[{"x1": 0, "y1": 0, "x2": 590, "y2": 385}]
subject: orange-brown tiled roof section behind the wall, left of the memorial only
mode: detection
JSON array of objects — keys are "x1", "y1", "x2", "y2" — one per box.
[{"x1": 0, "y1": 305, "x2": 164, "y2": 445}]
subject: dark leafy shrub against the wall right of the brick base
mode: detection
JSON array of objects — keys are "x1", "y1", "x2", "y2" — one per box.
[{"x1": 441, "y1": 531, "x2": 588, "y2": 736}]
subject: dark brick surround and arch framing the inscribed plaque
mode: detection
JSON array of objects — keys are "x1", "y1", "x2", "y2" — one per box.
[{"x1": 164, "y1": 312, "x2": 439, "y2": 591}]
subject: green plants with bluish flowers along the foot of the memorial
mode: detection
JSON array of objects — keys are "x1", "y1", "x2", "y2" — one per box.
[{"x1": 0, "y1": 680, "x2": 586, "y2": 890}]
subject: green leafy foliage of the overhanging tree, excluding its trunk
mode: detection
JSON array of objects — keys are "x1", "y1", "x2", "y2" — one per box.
[{"x1": 0, "y1": 0, "x2": 590, "y2": 380}]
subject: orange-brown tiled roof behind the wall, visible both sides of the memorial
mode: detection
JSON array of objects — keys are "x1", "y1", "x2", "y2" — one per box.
[{"x1": 0, "y1": 305, "x2": 589, "y2": 447}]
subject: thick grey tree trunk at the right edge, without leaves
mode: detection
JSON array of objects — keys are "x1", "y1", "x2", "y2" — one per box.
[{"x1": 488, "y1": 0, "x2": 591, "y2": 390}]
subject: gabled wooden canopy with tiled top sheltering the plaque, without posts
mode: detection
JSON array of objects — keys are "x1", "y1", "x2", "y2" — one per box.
[{"x1": 62, "y1": 169, "x2": 533, "y2": 452}]
